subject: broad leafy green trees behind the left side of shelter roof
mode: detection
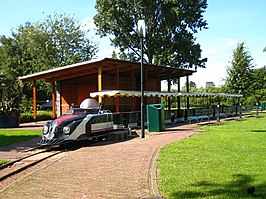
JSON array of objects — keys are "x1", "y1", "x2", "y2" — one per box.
[{"x1": 0, "y1": 14, "x2": 98, "y2": 106}]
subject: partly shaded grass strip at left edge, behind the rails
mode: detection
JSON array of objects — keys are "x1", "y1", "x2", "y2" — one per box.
[{"x1": 0, "y1": 129, "x2": 42, "y2": 147}]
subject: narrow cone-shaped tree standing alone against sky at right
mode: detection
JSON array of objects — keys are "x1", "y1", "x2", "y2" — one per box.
[{"x1": 225, "y1": 42, "x2": 254, "y2": 97}]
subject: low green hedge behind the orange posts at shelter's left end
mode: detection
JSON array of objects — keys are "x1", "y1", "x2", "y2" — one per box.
[{"x1": 20, "y1": 111, "x2": 52, "y2": 123}]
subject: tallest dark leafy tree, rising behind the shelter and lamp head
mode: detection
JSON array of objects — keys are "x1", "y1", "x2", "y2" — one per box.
[{"x1": 94, "y1": 0, "x2": 207, "y2": 68}]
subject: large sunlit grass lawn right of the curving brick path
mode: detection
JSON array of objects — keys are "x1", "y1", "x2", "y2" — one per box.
[{"x1": 158, "y1": 116, "x2": 266, "y2": 198}]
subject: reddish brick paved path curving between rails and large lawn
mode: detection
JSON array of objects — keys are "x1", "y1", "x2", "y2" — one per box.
[{"x1": 0, "y1": 125, "x2": 198, "y2": 199}]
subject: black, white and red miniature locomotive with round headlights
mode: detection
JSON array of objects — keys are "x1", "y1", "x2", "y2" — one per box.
[{"x1": 38, "y1": 98, "x2": 113, "y2": 146}]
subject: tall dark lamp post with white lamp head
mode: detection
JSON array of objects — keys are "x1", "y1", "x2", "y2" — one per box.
[{"x1": 138, "y1": 19, "x2": 146, "y2": 138}]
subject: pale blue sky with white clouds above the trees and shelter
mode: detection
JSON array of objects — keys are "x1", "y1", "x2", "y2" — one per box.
[{"x1": 0, "y1": 0, "x2": 266, "y2": 88}]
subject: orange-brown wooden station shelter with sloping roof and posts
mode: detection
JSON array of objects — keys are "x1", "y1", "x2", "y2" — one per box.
[{"x1": 20, "y1": 58, "x2": 195, "y2": 118}]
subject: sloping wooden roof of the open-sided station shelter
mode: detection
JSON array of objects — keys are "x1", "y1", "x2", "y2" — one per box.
[{"x1": 19, "y1": 58, "x2": 195, "y2": 82}]
